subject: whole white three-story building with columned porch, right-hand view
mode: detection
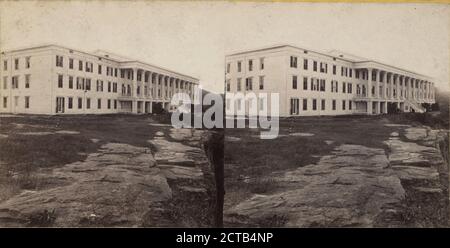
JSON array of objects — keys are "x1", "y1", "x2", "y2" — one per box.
[{"x1": 225, "y1": 45, "x2": 435, "y2": 116}]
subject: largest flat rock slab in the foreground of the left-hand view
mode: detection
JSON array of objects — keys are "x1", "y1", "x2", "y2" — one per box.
[{"x1": 0, "y1": 143, "x2": 172, "y2": 227}]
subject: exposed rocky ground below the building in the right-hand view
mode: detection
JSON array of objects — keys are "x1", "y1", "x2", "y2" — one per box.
[{"x1": 225, "y1": 116, "x2": 449, "y2": 227}]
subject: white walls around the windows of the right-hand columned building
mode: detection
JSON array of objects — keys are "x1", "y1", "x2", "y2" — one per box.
[{"x1": 225, "y1": 46, "x2": 434, "y2": 116}]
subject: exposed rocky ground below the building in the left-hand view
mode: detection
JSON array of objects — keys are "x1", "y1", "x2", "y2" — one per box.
[{"x1": 0, "y1": 114, "x2": 216, "y2": 227}]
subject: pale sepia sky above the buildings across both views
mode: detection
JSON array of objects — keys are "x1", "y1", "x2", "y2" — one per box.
[{"x1": 0, "y1": 1, "x2": 450, "y2": 92}]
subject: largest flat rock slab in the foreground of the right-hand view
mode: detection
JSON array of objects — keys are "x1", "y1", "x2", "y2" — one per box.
[{"x1": 225, "y1": 145, "x2": 405, "y2": 227}]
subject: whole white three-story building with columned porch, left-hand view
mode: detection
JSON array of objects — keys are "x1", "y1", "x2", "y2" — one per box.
[{"x1": 0, "y1": 45, "x2": 198, "y2": 114}]
